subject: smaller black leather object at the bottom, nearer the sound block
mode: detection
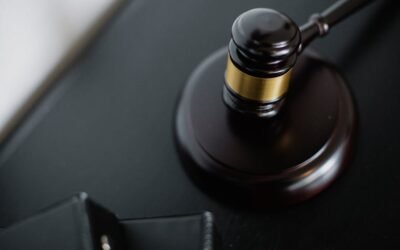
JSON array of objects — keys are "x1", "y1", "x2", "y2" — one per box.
[{"x1": 121, "y1": 212, "x2": 217, "y2": 250}]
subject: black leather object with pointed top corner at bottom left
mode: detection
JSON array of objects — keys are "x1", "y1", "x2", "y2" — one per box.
[{"x1": 0, "y1": 193, "x2": 126, "y2": 250}]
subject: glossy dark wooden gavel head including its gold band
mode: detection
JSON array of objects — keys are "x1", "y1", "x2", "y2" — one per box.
[{"x1": 223, "y1": 8, "x2": 301, "y2": 117}]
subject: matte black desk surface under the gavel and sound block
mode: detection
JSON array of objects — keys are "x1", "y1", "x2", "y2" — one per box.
[{"x1": 0, "y1": 0, "x2": 400, "y2": 250}]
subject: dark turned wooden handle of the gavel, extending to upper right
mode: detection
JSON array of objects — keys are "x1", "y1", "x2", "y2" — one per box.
[{"x1": 300, "y1": 0, "x2": 373, "y2": 49}]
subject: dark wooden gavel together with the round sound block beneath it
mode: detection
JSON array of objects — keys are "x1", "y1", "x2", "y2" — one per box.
[{"x1": 176, "y1": 0, "x2": 371, "y2": 203}]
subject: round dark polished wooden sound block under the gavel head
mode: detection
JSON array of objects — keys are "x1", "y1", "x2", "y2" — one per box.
[{"x1": 176, "y1": 48, "x2": 357, "y2": 204}]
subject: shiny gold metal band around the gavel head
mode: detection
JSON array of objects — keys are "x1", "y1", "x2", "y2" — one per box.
[{"x1": 225, "y1": 56, "x2": 292, "y2": 102}]
